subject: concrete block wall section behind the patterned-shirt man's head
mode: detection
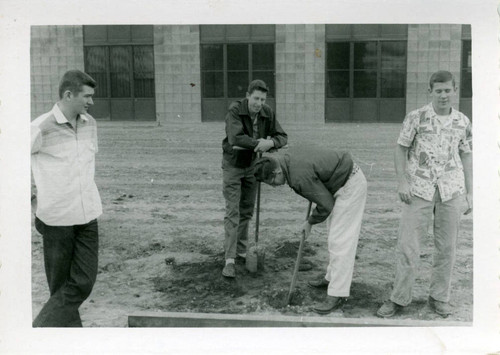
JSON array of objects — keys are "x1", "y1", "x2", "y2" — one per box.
[{"x1": 406, "y1": 24, "x2": 462, "y2": 112}]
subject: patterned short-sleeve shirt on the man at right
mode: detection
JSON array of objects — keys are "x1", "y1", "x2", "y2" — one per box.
[{"x1": 398, "y1": 103, "x2": 472, "y2": 201}]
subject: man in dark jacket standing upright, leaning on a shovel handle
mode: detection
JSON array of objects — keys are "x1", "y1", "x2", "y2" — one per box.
[{"x1": 222, "y1": 80, "x2": 287, "y2": 278}]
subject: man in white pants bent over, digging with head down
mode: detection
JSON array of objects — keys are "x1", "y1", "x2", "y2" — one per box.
[{"x1": 255, "y1": 147, "x2": 367, "y2": 314}]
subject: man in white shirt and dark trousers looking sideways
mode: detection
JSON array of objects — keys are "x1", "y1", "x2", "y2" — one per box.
[{"x1": 31, "y1": 70, "x2": 102, "y2": 327}]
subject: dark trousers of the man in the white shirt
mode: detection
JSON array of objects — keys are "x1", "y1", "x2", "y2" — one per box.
[{"x1": 33, "y1": 218, "x2": 99, "y2": 327}]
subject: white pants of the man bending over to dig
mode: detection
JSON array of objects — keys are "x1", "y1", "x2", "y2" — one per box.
[{"x1": 325, "y1": 169, "x2": 367, "y2": 297}]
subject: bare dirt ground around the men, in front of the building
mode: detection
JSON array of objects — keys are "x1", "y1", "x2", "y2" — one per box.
[{"x1": 32, "y1": 122, "x2": 473, "y2": 327}]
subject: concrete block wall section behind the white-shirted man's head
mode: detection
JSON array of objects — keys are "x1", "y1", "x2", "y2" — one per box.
[{"x1": 30, "y1": 26, "x2": 84, "y2": 120}]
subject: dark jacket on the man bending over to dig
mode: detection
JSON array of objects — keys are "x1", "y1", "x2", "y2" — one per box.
[{"x1": 283, "y1": 147, "x2": 353, "y2": 224}]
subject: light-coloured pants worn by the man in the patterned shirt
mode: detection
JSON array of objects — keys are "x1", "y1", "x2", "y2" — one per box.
[{"x1": 390, "y1": 189, "x2": 463, "y2": 306}]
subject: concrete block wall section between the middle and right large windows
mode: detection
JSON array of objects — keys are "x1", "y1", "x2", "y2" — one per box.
[{"x1": 276, "y1": 24, "x2": 326, "y2": 124}]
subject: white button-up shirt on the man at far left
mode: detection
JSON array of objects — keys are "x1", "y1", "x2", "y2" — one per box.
[{"x1": 31, "y1": 104, "x2": 102, "y2": 226}]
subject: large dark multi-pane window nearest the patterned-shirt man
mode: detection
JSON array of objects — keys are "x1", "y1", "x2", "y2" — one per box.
[{"x1": 325, "y1": 24, "x2": 408, "y2": 122}]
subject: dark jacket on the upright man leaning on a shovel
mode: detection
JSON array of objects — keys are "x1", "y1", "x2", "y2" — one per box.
[{"x1": 222, "y1": 99, "x2": 287, "y2": 168}]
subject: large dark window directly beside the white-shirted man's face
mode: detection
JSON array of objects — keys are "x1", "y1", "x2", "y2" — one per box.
[{"x1": 83, "y1": 25, "x2": 156, "y2": 120}]
